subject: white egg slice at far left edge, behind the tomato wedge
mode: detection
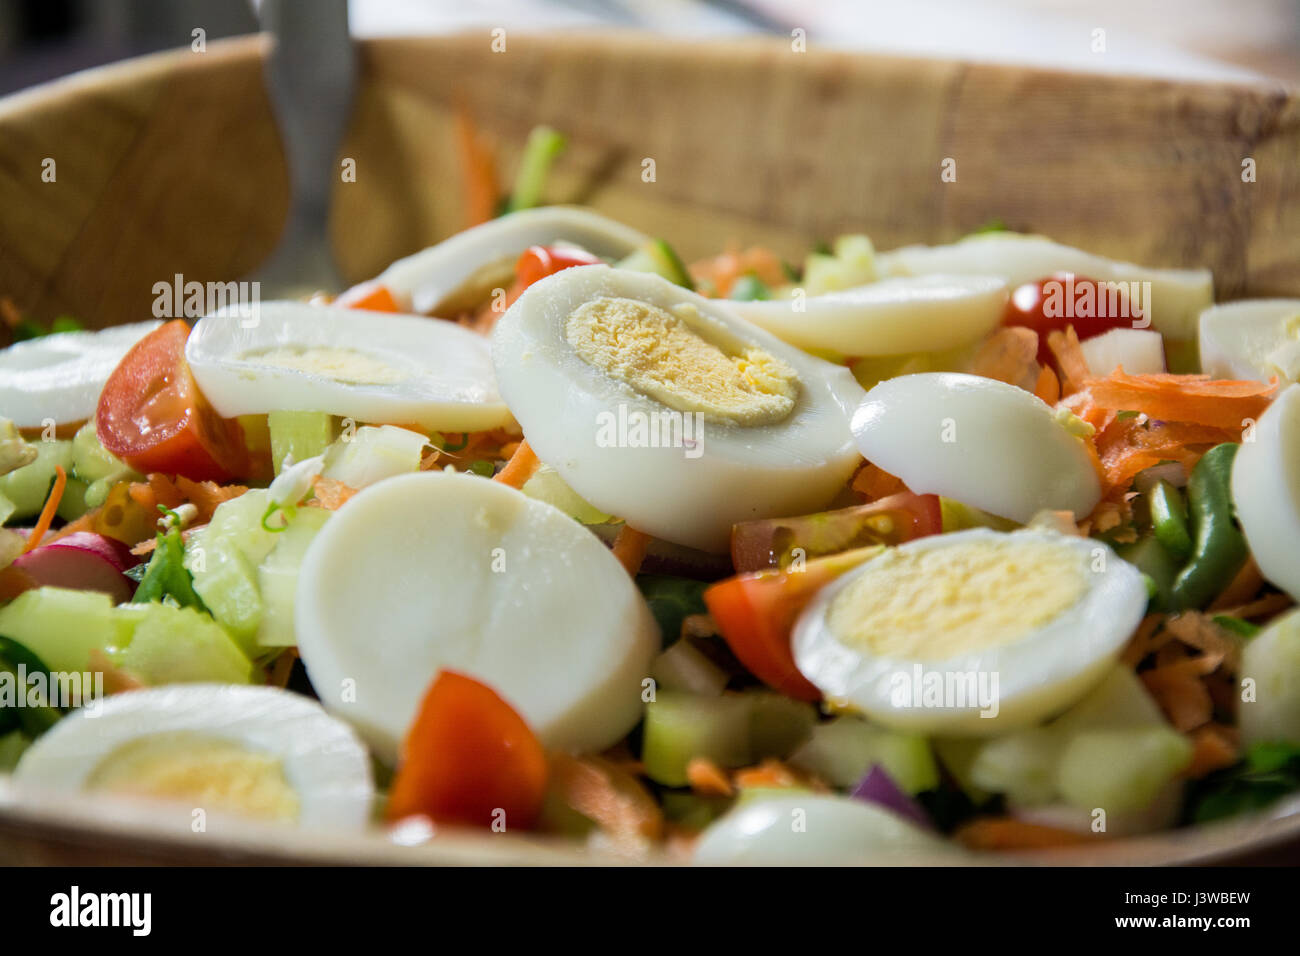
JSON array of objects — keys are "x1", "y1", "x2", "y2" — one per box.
[{"x1": 0, "y1": 321, "x2": 163, "y2": 428}]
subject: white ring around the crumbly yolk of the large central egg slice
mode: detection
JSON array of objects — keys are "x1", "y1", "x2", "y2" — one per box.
[{"x1": 493, "y1": 265, "x2": 863, "y2": 551}]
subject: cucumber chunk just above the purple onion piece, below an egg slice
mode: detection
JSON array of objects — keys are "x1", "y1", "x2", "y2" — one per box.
[{"x1": 790, "y1": 717, "x2": 939, "y2": 793}]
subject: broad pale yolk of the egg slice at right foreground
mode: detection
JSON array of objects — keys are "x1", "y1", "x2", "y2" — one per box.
[{"x1": 827, "y1": 541, "x2": 1088, "y2": 661}]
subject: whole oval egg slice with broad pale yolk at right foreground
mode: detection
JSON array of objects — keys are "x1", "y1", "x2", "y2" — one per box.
[{"x1": 793, "y1": 528, "x2": 1147, "y2": 736}]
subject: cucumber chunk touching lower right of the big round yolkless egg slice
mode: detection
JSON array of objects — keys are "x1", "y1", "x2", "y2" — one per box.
[{"x1": 641, "y1": 691, "x2": 751, "y2": 787}]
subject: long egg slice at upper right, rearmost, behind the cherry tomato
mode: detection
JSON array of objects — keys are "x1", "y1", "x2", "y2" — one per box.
[{"x1": 876, "y1": 233, "x2": 1214, "y2": 342}]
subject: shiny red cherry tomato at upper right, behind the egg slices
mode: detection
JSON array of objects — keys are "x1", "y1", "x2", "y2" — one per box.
[{"x1": 1002, "y1": 278, "x2": 1135, "y2": 365}]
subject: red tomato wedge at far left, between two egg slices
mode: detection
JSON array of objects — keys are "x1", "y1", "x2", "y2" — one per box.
[{"x1": 95, "y1": 319, "x2": 248, "y2": 484}]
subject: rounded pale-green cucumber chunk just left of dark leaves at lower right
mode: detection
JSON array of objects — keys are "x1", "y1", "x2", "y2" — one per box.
[{"x1": 1057, "y1": 726, "x2": 1192, "y2": 813}]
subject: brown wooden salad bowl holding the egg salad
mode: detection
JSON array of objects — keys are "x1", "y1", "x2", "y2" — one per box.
[{"x1": 0, "y1": 33, "x2": 1300, "y2": 864}]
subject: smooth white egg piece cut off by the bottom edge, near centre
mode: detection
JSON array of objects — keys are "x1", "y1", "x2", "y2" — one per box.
[{"x1": 693, "y1": 793, "x2": 962, "y2": 866}]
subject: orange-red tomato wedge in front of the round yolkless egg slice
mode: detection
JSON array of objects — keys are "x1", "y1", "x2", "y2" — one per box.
[{"x1": 387, "y1": 671, "x2": 547, "y2": 830}]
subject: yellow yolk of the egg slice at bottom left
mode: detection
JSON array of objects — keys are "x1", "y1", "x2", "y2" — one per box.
[{"x1": 86, "y1": 732, "x2": 299, "y2": 821}]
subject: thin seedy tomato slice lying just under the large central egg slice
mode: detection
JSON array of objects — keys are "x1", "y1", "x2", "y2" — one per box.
[{"x1": 732, "y1": 492, "x2": 944, "y2": 571}]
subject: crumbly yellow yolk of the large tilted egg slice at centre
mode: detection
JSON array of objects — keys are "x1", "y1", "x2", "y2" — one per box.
[{"x1": 564, "y1": 297, "x2": 800, "y2": 425}]
